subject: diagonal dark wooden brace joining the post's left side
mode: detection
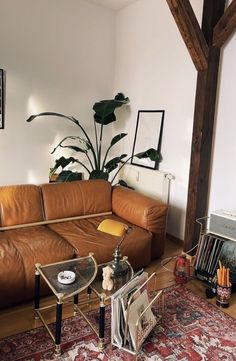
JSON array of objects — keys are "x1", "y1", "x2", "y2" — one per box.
[{"x1": 166, "y1": 0, "x2": 208, "y2": 71}]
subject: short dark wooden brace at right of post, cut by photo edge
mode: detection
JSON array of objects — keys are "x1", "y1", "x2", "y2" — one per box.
[{"x1": 213, "y1": 0, "x2": 236, "y2": 48}]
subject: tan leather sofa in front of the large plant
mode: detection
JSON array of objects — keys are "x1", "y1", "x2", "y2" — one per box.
[{"x1": 0, "y1": 180, "x2": 167, "y2": 307}]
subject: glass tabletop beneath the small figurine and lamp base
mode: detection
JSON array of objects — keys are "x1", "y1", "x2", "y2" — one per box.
[{"x1": 90, "y1": 259, "x2": 134, "y2": 300}]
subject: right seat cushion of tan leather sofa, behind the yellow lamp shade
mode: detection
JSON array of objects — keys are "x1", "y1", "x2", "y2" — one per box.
[{"x1": 49, "y1": 215, "x2": 152, "y2": 269}]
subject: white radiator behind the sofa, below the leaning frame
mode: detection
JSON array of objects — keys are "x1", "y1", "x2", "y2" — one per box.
[{"x1": 119, "y1": 164, "x2": 173, "y2": 203}]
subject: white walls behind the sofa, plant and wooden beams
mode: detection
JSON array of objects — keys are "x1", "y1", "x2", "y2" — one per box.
[{"x1": 0, "y1": 0, "x2": 236, "y2": 239}]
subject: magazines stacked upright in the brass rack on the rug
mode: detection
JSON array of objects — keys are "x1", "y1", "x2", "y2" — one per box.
[{"x1": 111, "y1": 272, "x2": 158, "y2": 351}]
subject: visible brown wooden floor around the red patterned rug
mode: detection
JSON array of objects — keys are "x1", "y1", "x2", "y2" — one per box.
[{"x1": 0, "y1": 240, "x2": 236, "y2": 338}]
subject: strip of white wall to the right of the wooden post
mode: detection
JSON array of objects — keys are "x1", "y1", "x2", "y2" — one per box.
[{"x1": 209, "y1": 34, "x2": 236, "y2": 214}]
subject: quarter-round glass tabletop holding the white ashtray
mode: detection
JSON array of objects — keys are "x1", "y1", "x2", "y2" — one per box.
[{"x1": 36, "y1": 255, "x2": 98, "y2": 299}]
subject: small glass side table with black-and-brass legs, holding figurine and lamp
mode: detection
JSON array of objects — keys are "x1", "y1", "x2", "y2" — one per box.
[{"x1": 75, "y1": 257, "x2": 134, "y2": 351}]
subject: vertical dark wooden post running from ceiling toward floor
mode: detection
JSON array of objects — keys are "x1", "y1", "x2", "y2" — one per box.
[{"x1": 184, "y1": 0, "x2": 225, "y2": 250}]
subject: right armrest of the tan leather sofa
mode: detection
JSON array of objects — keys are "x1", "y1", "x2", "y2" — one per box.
[{"x1": 112, "y1": 186, "x2": 168, "y2": 258}]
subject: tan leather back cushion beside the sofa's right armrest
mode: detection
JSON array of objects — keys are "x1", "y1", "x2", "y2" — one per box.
[{"x1": 42, "y1": 179, "x2": 111, "y2": 220}]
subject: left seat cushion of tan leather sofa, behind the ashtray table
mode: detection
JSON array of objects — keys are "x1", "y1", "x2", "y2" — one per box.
[{"x1": 0, "y1": 226, "x2": 74, "y2": 304}]
